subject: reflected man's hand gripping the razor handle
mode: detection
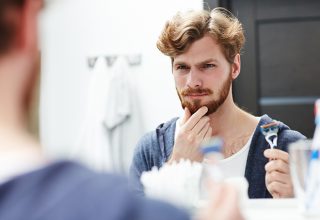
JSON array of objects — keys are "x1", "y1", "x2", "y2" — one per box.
[{"x1": 264, "y1": 149, "x2": 293, "y2": 198}]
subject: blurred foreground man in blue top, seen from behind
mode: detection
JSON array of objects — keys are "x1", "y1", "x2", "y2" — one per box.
[{"x1": 0, "y1": 0, "x2": 243, "y2": 220}]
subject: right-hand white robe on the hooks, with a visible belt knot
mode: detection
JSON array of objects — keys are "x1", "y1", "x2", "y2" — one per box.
[{"x1": 104, "y1": 56, "x2": 144, "y2": 174}]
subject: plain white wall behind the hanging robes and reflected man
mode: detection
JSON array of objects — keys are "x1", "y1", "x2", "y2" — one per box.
[{"x1": 40, "y1": 0, "x2": 202, "y2": 156}]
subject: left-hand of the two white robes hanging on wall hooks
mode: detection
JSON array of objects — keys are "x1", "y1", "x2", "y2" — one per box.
[{"x1": 71, "y1": 57, "x2": 113, "y2": 171}]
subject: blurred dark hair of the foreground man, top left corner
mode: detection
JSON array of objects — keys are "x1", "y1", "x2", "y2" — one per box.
[{"x1": 0, "y1": 0, "x2": 25, "y2": 55}]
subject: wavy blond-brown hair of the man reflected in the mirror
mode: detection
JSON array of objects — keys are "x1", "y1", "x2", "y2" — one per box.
[{"x1": 157, "y1": 7, "x2": 245, "y2": 63}]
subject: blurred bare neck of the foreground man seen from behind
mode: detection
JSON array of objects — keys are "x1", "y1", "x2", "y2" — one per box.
[{"x1": 0, "y1": 55, "x2": 38, "y2": 156}]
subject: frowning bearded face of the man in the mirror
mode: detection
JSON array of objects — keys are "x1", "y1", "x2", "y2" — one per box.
[{"x1": 173, "y1": 36, "x2": 233, "y2": 115}]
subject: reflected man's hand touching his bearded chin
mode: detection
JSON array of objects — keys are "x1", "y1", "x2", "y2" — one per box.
[{"x1": 169, "y1": 106, "x2": 212, "y2": 163}]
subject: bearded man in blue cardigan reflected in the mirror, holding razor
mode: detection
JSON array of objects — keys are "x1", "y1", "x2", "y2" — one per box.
[{"x1": 130, "y1": 8, "x2": 305, "y2": 198}]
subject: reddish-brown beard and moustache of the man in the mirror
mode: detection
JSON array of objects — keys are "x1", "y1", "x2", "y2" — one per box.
[{"x1": 177, "y1": 74, "x2": 232, "y2": 115}]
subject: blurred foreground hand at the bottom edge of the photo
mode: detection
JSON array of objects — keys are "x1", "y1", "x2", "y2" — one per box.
[{"x1": 195, "y1": 183, "x2": 244, "y2": 220}]
